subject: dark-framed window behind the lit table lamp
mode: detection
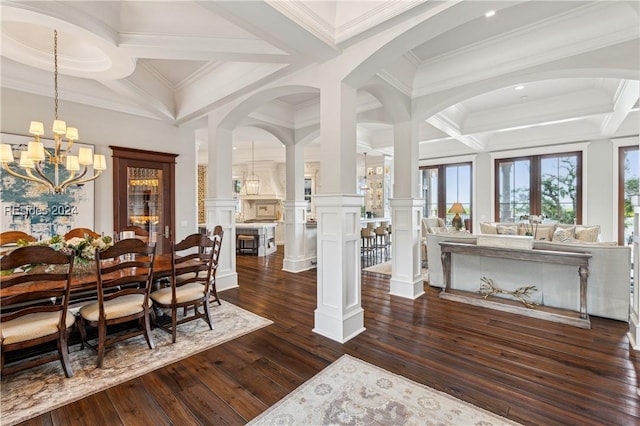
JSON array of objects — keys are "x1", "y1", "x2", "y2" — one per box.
[{"x1": 420, "y1": 163, "x2": 471, "y2": 228}]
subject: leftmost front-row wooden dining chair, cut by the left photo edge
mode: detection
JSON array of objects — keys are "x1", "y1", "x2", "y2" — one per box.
[{"x1": 0, "y1": 246, "x2": 75, "y2": 377}]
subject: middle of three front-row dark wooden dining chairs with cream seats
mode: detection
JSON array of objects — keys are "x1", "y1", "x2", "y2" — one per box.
[{"x1": 78, "y1": 238, "x2": 156, "y2": 368}]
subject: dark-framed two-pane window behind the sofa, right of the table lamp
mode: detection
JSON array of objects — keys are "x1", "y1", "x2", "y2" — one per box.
[{"x1": 495, "y1": 152, "x2": 582, "y2": 223}]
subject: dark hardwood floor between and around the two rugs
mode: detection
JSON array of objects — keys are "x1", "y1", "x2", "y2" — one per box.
[{"x1": 20, "y1": 248, "x2": 640, "y2": 425}]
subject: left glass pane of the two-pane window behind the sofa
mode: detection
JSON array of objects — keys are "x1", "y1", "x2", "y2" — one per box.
[{"x1": 498, "y1": 159, "x2": 531, "y2": 222}]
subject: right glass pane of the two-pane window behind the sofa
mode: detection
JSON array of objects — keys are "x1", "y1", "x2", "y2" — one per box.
[{"x1": 540, "y1": 155, "x2": 578, "y2": 223}]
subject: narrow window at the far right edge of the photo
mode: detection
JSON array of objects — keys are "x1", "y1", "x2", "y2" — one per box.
[{"x1": 618, "y1": 145, "x2": 640, "y2": 245}]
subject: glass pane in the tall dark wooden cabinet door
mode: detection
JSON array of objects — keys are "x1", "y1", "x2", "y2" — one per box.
[{"x1": 127, "y1": 167, "x2": 164, "y2": 241}]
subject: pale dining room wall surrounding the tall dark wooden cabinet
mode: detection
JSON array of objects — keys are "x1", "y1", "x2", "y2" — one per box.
[{"x1": 0, "y1": 89, "x2": 197, "y2": 240}]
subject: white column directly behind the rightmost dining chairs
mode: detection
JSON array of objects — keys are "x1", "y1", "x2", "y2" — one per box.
[{"x1": 205, "y1": 115, "x2": 238, "y2": 291}]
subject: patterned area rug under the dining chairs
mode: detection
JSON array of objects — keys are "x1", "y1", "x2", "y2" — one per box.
[{"x1": 0, "y1": 301, "x2": 272, "y2": 425}]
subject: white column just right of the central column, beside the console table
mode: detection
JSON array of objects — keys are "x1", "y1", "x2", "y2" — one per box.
[{"x1": 389, "y1": 121, "x2": 424, "y2": 299}]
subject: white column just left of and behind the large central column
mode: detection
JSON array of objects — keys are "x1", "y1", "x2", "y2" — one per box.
[{"x1": 282, "y1": 144, "x2": 316, "y2": 272}]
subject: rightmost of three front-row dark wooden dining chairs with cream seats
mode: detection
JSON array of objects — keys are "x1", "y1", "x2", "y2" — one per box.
[{"x1": 151, "y1": 225, "x2": 224, "y2": 343}]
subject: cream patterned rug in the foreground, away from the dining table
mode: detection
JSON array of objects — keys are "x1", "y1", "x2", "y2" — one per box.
[{"x1": 249, "y1": 355, "x2": 519, "y2": 426}]
